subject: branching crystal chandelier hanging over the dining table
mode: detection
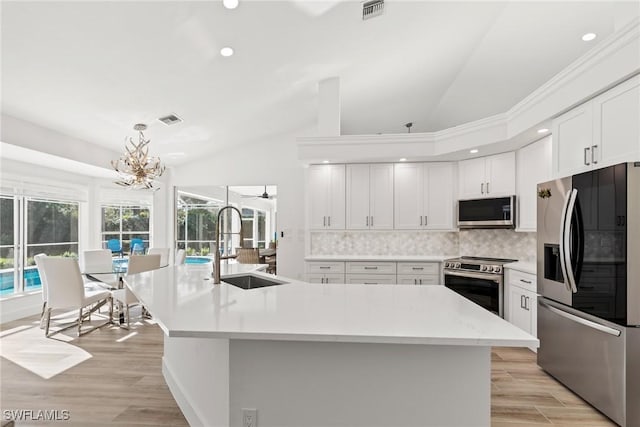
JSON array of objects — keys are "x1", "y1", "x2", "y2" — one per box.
[{"x1": 111, "y1": 123, "x2": 165, "y2": 190}]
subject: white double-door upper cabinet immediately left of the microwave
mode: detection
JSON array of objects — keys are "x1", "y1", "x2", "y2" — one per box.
[{"x1": 394, "y1": 163, "x2": 455, "y2": 230}]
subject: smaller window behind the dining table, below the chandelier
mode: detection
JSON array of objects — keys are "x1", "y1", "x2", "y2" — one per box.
[{"x1": 102, "y1": 205, "x2": 151, "y2": 253}]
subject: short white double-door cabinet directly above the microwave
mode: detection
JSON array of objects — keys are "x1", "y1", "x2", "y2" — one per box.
[{"x1": 458, "y1": 152, "x2": 516, "y2": 199}]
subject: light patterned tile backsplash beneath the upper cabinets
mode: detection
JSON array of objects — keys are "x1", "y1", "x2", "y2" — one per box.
[{"x1": 310, "y1": 230, "x2": 536, "y2": 261}]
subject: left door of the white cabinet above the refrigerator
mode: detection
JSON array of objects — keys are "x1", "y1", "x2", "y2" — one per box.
[{"x1": 552, "y1": 102, "x2": 596, "y2": 176}]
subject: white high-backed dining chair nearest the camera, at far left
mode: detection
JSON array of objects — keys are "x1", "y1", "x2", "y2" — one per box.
[{"x1": 38, "y1": 256, "x2": 113, "y2": 337}]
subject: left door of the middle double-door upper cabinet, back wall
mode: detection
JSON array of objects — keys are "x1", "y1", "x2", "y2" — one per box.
[{"x1": 347, "y1": 165, "x2": 369, "y2": 230}]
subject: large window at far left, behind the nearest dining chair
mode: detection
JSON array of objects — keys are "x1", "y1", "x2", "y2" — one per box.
[{"x1": 0, "y1": 196, "x2": 78, "y2": 296}]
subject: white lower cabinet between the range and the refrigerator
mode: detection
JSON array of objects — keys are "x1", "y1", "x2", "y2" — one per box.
[{"x1": 505, "y1": 269, "x2": 538, "y2": 351}]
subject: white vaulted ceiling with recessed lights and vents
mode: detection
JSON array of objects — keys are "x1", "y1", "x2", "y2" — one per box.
[{"x1": 1, "y1": 0, "x2": 640, "y2": 165}]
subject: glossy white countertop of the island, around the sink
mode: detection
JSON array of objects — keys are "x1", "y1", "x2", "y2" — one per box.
[{"x1": 126, "y1": 264, "x2": 538, "y2": 347}]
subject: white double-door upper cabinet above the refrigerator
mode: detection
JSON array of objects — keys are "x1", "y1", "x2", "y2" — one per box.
[{"x1": 553, "y1": 76, "x2": 640, "y2": 176}]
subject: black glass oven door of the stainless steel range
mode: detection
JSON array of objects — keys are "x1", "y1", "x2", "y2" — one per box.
[{"x1": 444, "y1": 270, "x2": 504, "y2": 317}]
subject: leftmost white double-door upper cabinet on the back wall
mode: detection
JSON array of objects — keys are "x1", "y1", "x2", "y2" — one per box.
[{"x1": 308, "y1": 165, "x2": 345, "y2": 229}]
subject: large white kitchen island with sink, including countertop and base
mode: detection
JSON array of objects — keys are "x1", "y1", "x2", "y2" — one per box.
[{"x1": 126, "y1": 265, "x2": 538, "y2": 427}]
